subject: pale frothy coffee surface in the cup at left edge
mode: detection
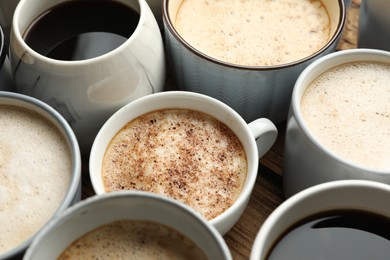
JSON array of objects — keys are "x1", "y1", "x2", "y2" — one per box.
[{"x1": 0, "y1": 105, "x2": 71, "y2": 254}]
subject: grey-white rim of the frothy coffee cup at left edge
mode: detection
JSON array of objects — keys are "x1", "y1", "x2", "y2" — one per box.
[{"x1": 0, "y1": 91, "x2": 82, "y2": 259}]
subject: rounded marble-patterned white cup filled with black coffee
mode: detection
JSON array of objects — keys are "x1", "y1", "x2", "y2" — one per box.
[{"x1": 10, "y1": 0, "x2": 165, "y2": 153}]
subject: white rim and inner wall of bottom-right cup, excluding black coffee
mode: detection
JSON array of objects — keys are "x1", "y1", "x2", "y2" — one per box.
[{"x1": 250, "y1": 180, "x2": 390, "y2": 260}]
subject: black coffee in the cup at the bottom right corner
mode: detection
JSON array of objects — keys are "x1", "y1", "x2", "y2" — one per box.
[{"x1": 267, "y1": 210, "x2": 390, "y2": 260}]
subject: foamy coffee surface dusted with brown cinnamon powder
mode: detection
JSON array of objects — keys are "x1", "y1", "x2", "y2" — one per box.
[{"x1": 102, "y1": 109, "x2": 247, "y2": 219}]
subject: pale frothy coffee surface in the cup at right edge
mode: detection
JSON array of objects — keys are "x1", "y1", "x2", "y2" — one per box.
[{"x1": 301, "y1": 62, "x2": 390, "y2": 171}]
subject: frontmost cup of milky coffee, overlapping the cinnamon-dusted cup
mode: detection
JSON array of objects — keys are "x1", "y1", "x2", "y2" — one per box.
[{"x1": 24, "y1": 191, "x2": 232, "y2": 260}]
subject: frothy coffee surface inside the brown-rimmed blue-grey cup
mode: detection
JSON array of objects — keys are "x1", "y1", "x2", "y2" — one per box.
[{"x1": 175, "y1": 0, "x2": 331, "y2": 66}]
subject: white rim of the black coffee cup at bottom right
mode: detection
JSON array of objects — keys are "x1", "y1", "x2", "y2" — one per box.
[{"x1": 250, "y1": 179, "x2": 390, "y2": 260}]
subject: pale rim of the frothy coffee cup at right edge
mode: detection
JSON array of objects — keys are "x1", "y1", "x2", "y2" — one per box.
[{"x1": 290, "y1": 48, "x2": 390, "y2": 176}]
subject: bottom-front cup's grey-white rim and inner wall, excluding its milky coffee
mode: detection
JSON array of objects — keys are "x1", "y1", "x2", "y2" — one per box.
[{"x1": 24, "y1": 191, "x2": 232, "y2": 260}]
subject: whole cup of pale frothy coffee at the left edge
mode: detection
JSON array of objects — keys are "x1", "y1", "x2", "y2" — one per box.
[{"x1": 0, "y1": 92, "x2": 81, "y2": 259}]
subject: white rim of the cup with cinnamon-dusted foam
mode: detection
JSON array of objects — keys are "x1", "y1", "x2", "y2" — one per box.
[{"x1": 89, "y1": 91, "x2": 259, "y2": 234}]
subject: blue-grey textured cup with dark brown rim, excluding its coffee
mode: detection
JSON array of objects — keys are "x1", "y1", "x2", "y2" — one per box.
[{"x1": 162, "y1": 0, "x2": 345, "y2": 124}]
